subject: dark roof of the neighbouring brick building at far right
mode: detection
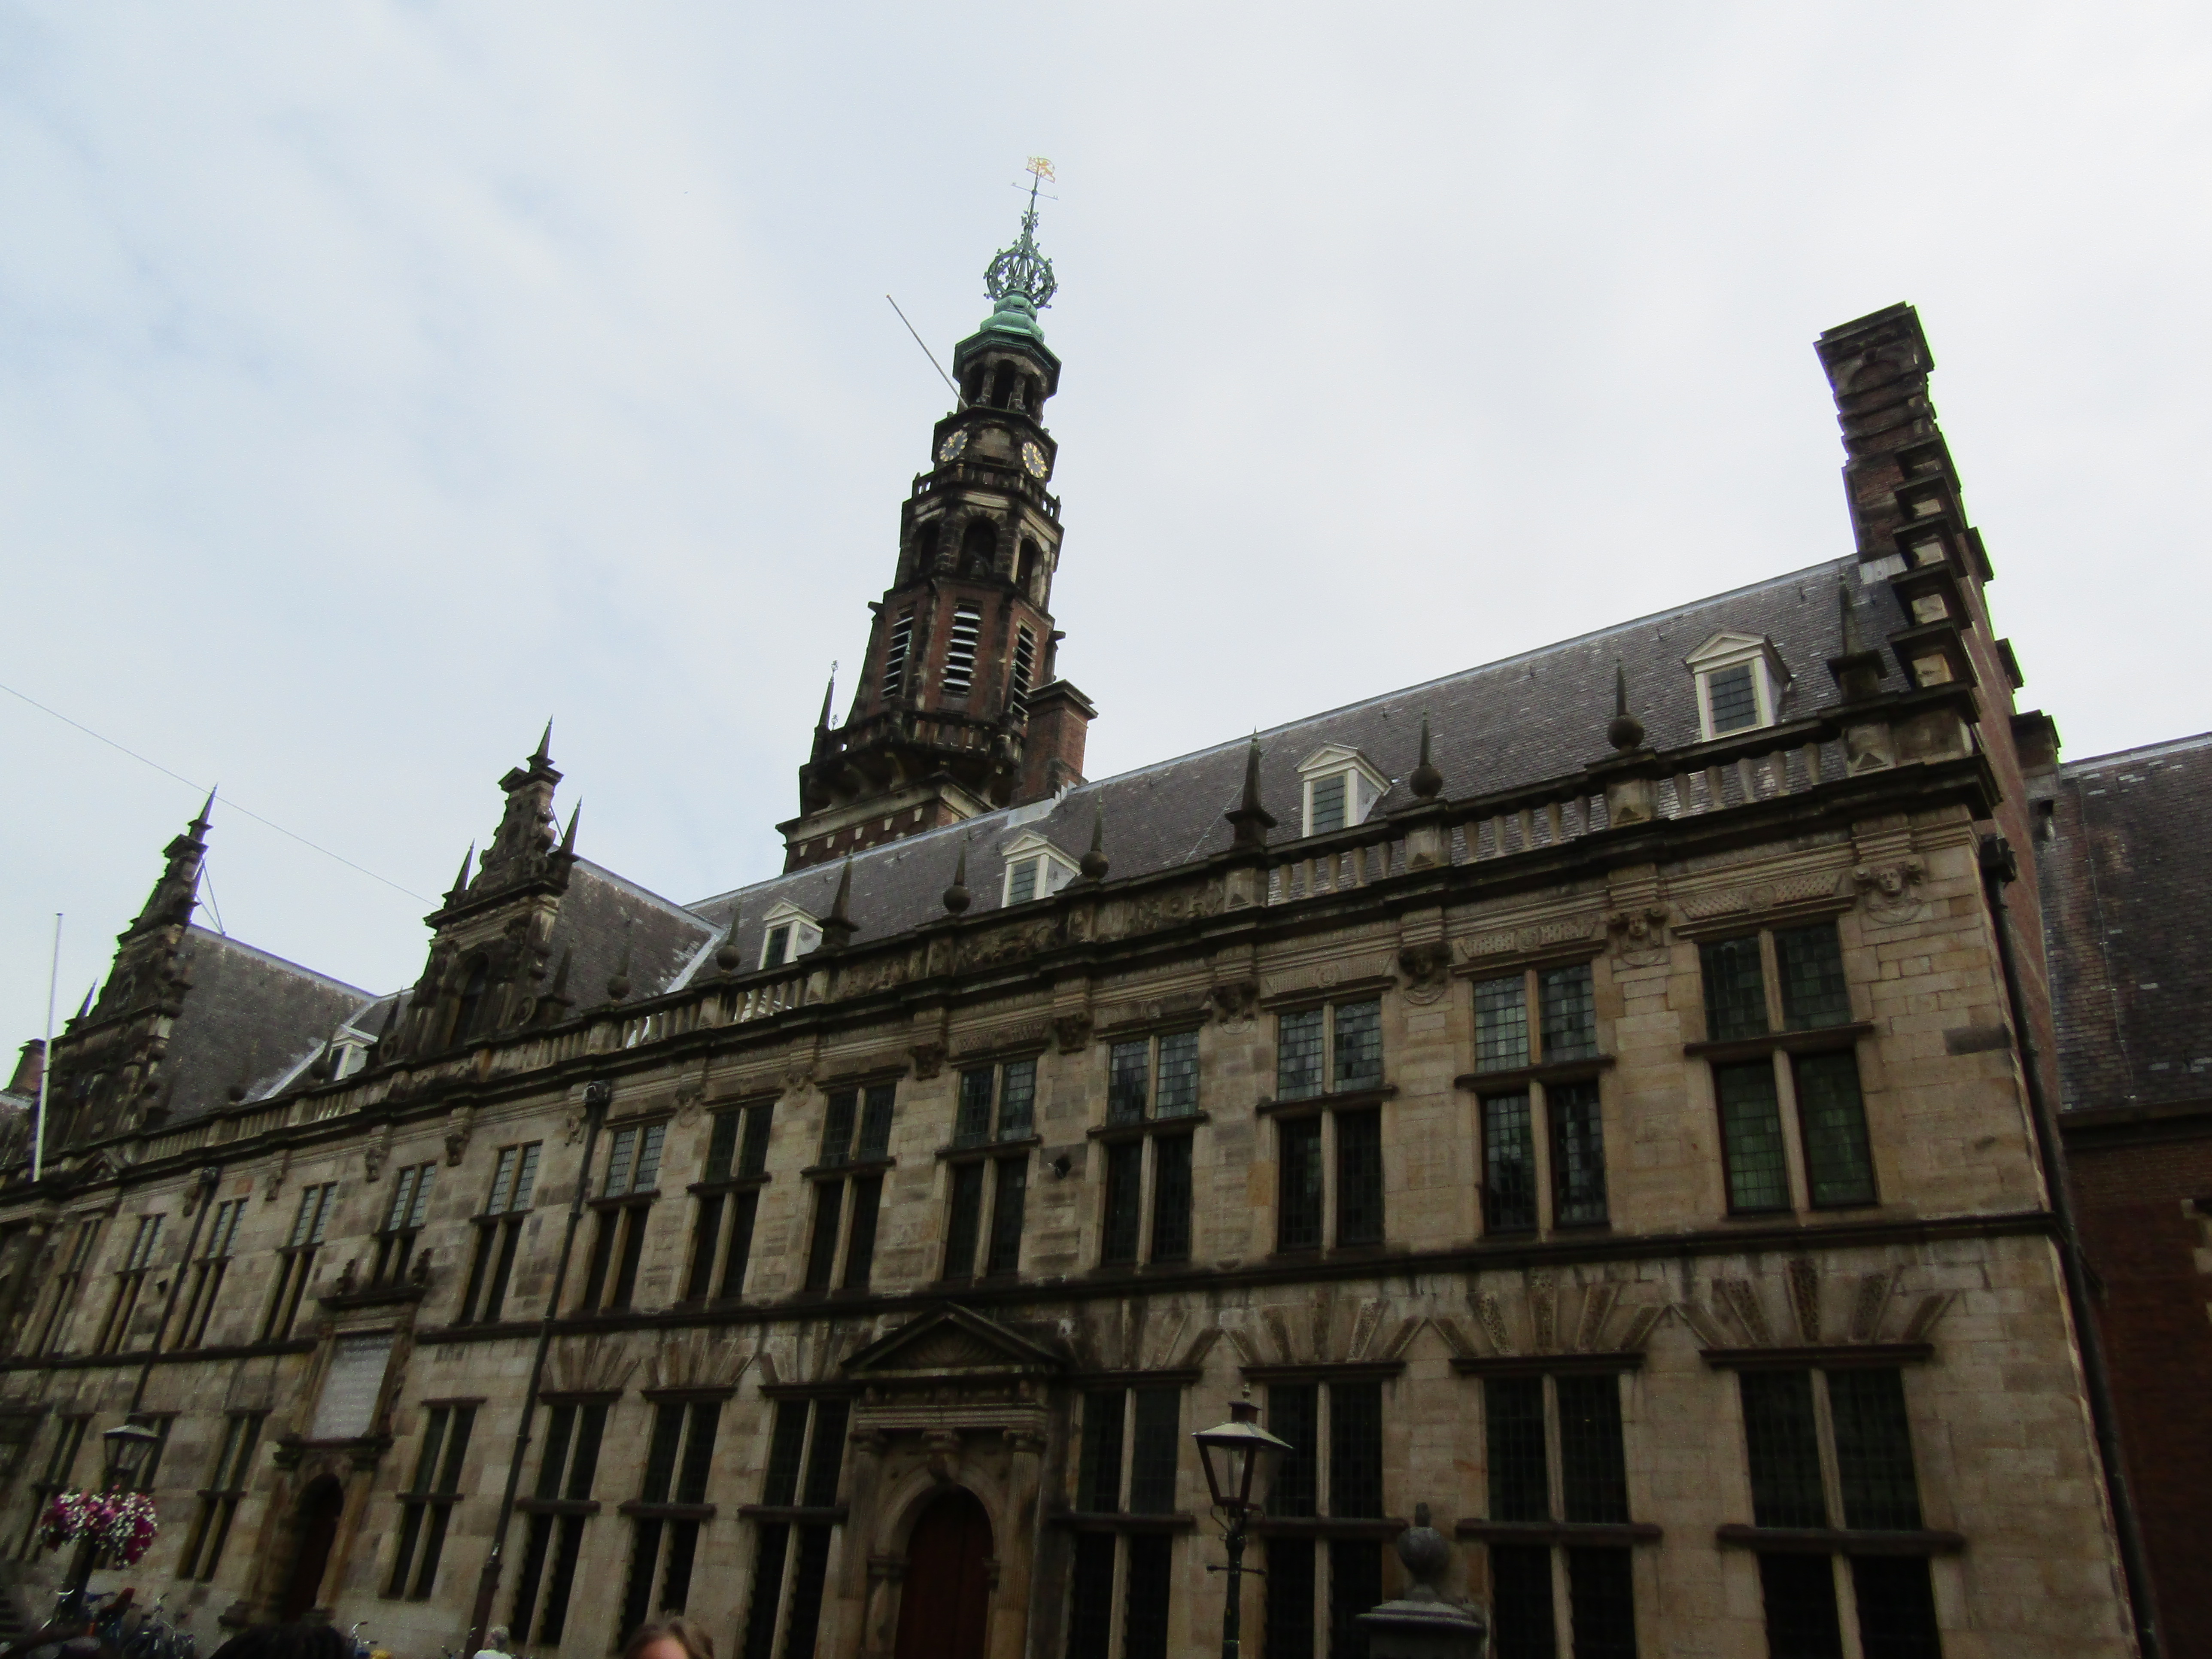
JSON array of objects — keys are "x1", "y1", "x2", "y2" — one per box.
[{"x1": 2035, "y1": 732, "x2": 2212, "y2": 1108}]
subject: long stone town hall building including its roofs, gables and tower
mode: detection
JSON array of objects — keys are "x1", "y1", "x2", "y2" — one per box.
[{"x1": 0, "y1": 204, "x2": 2137, "y2": 1659}]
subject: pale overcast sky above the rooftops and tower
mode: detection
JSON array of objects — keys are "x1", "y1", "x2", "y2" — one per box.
[{"x1": 0, "y1": 0, "x2": 2212, "y2": 1051}]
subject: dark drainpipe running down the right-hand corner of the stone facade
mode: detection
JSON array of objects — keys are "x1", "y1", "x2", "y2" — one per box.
[{"x1": 1980, "y1": 836, "x2": 2163, "y2": 1659}]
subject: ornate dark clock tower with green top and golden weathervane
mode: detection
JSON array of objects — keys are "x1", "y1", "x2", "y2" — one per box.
[{"x1": 776, "y1": 176, "x2": 1095, "y2": 869}]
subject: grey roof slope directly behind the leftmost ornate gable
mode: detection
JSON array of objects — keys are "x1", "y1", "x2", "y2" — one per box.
[{"x1": 159, "y1": 925, "x2": 376, "y2": 1121}]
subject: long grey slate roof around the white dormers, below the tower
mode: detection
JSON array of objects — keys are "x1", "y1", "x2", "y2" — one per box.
[{"x1": 690, "y1": 557, "x2": 1905, "y2": 966}]
